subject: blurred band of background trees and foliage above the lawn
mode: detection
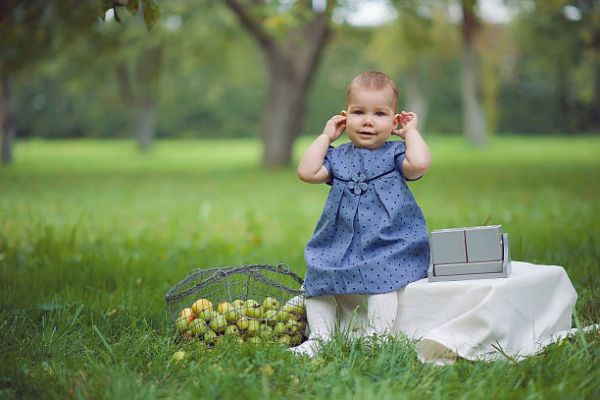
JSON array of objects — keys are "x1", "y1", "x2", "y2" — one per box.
[{"x1": 0, "y1": 0, "x2": 600, "y2": 165}]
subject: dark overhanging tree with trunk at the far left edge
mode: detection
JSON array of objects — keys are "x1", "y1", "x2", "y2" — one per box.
[{"x1": 0, "y1": 0, "x2": 158, "y2": 164}]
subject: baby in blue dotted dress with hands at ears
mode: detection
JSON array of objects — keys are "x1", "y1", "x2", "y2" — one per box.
[{"x1": 295, "y1": 71, "x2": 431, "y2": 355}]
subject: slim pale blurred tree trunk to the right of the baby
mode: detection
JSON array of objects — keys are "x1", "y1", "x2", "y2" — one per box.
[{"x1": 461, "y1": 0, "x2": 487, "y2": 146}]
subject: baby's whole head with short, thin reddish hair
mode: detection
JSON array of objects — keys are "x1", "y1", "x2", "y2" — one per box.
[{"x1": 342, "y1": 71, "x2": 399, "y2": 149}]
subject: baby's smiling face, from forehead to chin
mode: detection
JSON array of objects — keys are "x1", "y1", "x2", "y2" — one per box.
[{"x1": 342, "y1": 87, "x2": 399, "y2": 149}]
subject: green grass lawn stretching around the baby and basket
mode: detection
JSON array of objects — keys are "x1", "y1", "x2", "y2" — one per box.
[{"x1": 0, "y1": 137, "x2": 600, "y2": 399}]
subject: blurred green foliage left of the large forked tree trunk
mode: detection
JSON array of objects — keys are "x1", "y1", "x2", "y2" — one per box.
[{"x1": 11, "y1": 1, "x2": 264, "y2": 141}]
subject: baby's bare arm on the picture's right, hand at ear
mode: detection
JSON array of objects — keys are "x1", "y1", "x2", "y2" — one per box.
[{"x1": 394, "y1": 111, "x2": 431, "y2": 179}]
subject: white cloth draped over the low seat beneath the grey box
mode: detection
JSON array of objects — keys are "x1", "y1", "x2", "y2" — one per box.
[{"x1": 307, "y1": 261, "x2": 577, "y2": 364}]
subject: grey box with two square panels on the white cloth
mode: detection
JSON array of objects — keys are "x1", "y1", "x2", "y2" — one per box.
[{"x1": 429, "y1": 225, "x2": 510, "y2": 282}]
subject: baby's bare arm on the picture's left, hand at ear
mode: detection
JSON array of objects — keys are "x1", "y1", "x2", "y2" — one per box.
[{"x1": 298, "y1": 115, "x2": 346, "y2": 183}]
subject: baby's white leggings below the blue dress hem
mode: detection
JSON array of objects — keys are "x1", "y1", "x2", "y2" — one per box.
[{"x1": 305, "y1": 292, "x2": 398, "y2": 339}]
